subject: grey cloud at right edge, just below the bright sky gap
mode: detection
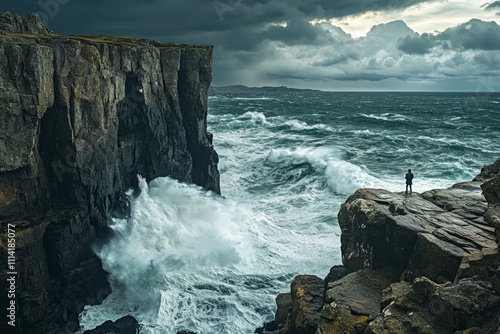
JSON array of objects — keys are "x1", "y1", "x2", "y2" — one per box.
[{"x1": 398, "y1": 19, "x2": 500, "y2": 54}]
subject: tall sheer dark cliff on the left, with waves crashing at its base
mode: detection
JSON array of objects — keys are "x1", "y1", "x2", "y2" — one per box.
[{"x1": 0, "y1": 12, "x2": 220, "y2": 333}]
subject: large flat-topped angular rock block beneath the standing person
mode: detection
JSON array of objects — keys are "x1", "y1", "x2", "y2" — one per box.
[{"x1": 339, "y1": 187, "x2": 496, "y2": 280}]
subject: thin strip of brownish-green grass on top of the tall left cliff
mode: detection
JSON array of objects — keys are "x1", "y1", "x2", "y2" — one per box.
[{"x1": 0, "y1": 30, "x2": 209, "y2": 49}]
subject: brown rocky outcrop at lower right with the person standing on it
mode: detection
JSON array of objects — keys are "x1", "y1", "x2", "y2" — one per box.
[{"x1": 268, "y1": 159, "x2": 500, "y2": 334}]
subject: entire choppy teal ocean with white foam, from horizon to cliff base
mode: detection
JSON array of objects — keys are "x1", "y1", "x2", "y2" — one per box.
[{"x1": 81, "y1": 91, "x2": 500, "y2": 334}]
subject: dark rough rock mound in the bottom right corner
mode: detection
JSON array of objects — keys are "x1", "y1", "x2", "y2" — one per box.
[{"x1": 366, "y1": 277, "x2": 500, "y2": 334}]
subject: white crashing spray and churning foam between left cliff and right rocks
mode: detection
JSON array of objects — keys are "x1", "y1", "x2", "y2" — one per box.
[{"x1": 81, "y1": 174, "x2": 338, "y2": 334}]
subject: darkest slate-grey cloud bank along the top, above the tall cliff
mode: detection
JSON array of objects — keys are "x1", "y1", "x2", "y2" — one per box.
[{"x1": 0, "y1": 0, "x2": 430, "y2": 37}]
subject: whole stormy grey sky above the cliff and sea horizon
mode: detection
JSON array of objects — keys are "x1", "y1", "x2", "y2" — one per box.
[{"x1": 0, "y1": 0, "x2": 500, "y2": 92}]
